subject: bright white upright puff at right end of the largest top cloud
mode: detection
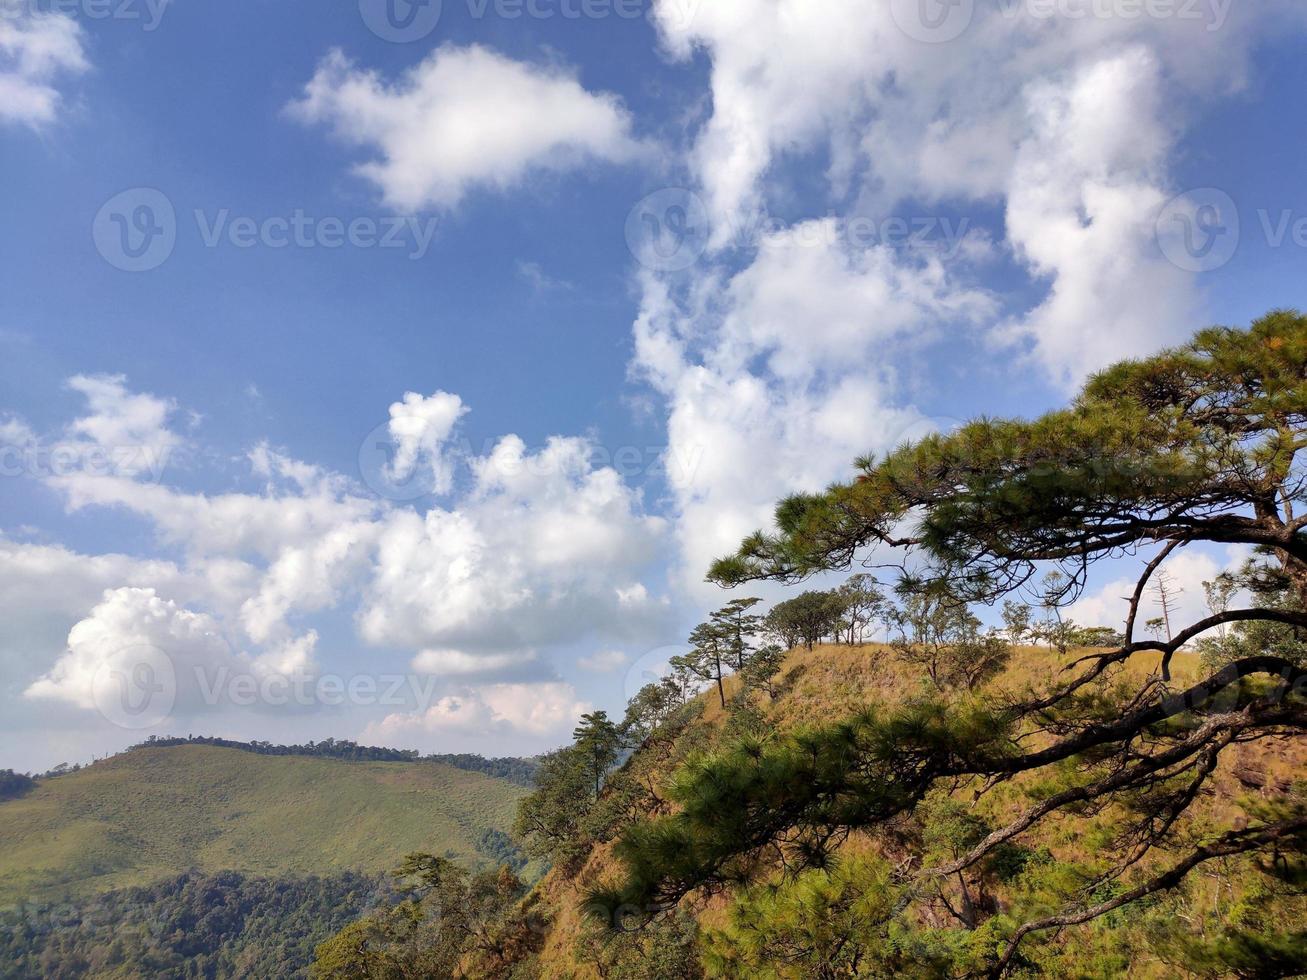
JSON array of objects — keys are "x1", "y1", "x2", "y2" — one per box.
[{"x1": 1006, "y1": 47, "x2": 1197, "y2": 387}]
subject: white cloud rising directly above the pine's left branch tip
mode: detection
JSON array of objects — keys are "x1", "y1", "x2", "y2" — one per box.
[{"x1": 634, "y1": 221, "x2": 993, "y2": 590}]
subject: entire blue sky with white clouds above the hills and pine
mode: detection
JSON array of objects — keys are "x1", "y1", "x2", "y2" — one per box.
[{"x1": 0, "y1": 0, "x2": 1307, "y2": 770}]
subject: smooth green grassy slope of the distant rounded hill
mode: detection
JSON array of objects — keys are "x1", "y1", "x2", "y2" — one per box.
[{"x1": 0, "y1": 745, "x2": 528, "y2": 906}]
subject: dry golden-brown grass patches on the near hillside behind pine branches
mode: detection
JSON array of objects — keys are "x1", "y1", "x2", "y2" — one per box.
[{"x1": 512, "y1": 645, "x2": 1307, "y2": 980}]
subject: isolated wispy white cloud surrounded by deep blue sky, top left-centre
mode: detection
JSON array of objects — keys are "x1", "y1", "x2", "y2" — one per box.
[{"x1": 290, "y1": 44, "x2": 639, "y2": 209}]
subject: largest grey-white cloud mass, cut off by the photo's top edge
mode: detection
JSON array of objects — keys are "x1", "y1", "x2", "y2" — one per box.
[{"x1": 655, "y1": 0, "x2": 1304, "y2": 384}]
